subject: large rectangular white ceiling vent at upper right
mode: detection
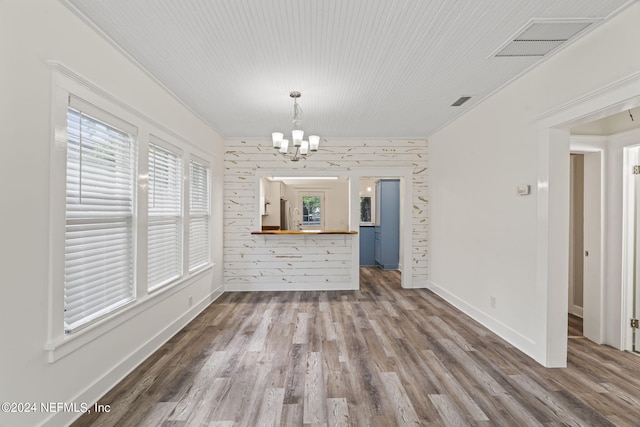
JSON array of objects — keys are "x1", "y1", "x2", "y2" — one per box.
[{"x1": 493, "y1": 19, "x2": 595, "y2": 58}]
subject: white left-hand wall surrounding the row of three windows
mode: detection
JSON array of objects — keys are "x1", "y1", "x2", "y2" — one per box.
[{"x1": 0, "y1": 0, "x2": 223, "y2": 426}]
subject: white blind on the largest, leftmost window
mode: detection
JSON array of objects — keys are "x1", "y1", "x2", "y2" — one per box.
[{"x1": 64, "y1": 102, "x2": 135, "y2": 332}]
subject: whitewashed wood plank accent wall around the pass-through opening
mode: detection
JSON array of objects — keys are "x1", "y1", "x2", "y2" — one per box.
[{"x1": 224, "y1": 139, "x2": 428, "y2": 290}]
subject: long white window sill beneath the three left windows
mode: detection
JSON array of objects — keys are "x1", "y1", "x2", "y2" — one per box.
[{"x1": 44, "y1": 263, "x2": 215, "y2": 363}]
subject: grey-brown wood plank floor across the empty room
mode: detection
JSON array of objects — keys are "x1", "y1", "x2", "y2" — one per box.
[{"x1": 74, "y1": 268, "x2": 640, "y2": 427}]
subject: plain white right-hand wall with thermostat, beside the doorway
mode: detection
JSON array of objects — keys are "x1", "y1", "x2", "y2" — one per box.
[{"x1": 429, "y1": 4, "x2": 640, "y2": 363}]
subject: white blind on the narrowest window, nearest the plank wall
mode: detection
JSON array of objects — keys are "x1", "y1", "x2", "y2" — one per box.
[{"x1": 189, "y1": 160, "x2": 210, "y2": 270}]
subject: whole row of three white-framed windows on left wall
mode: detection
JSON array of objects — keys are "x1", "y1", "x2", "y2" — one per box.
[{"x1": 45, "y1": 68, "x2": 218, "y2": 362}]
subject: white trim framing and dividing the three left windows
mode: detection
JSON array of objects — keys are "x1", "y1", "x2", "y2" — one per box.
[{"x1": 44, "y1": 61, "x2": 214, "y2": 363}]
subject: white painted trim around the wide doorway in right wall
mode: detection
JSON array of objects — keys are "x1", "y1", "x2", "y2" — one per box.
[{"x1": 535, "y1": 73, "x2": 640, "y2": 367}]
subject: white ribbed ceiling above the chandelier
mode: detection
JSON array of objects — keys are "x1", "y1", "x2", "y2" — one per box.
[{"x1": 63, "y1": 0, "x2": 633, "y2": 138}]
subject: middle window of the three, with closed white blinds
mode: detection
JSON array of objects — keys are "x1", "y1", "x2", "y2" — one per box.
[{"x1": 147, "y1": 136, "x2": 182, "y2": 289}]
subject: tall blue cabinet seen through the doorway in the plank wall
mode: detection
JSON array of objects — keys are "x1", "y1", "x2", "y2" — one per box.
[{"x1": 374, "y1": 179, "x2": 400, "y2": 270}]
